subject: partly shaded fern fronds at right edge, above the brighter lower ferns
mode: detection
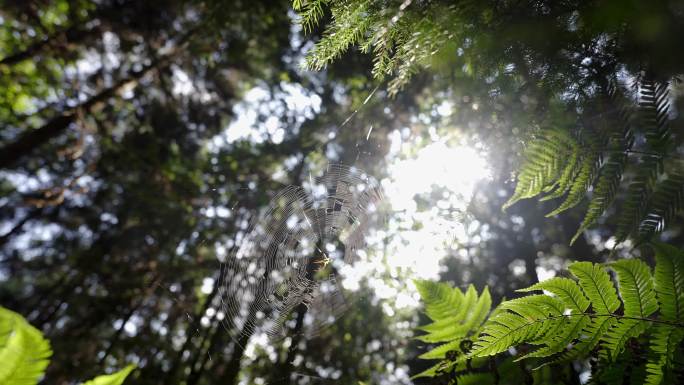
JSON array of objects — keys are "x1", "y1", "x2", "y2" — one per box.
[{"x1": 503, "y1": 79, "x2": 684, "y2": 242}]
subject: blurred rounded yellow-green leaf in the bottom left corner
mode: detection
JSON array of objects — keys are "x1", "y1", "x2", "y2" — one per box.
[{"x1": 0, "y1": 307, "x2": 52, "y2": 385}]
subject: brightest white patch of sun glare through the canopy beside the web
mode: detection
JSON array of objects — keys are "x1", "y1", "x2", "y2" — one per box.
[{"x1": 382, "y1": 136, "x2": 491, "y2": 278}]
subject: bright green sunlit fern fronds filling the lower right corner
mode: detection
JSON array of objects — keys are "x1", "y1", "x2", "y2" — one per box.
[{"x1": 418, "y1": 244, "x2": 684, "y2": 384}]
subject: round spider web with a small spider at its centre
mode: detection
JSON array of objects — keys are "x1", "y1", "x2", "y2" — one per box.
[{"x1": 219, "y1": 164, "x2": 382, "y2": 341}]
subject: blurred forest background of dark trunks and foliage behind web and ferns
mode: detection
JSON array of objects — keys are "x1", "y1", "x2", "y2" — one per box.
[{"x1": 0, "y1": 0, "x2": 684, "y2": 385}]
